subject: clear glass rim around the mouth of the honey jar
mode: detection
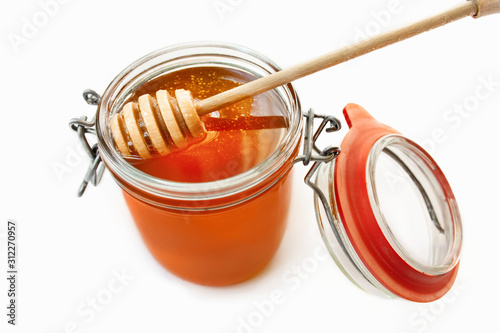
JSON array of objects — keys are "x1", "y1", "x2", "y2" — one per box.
[{"x1": 96, "y1": 41, "x2": 302, "y2": 208}]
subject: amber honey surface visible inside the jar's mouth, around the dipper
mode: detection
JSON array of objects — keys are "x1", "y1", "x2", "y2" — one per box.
[{"x1": 128, "y1": 67, "x2": 286, "y2": 182}]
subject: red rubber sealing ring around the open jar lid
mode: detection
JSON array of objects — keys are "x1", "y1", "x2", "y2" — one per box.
[{"x1": 334, "y1": 104, "x2": 458, "y2": 302}]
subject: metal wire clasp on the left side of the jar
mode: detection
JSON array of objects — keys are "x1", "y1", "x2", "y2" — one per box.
[{"x1": 69, "y1": 89, "x2": 105, "y2": 197}]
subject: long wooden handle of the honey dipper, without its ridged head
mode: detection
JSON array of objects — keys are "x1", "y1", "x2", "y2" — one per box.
[{"x1": 196, "y1": 0, "x2": 500, "y2": 116}]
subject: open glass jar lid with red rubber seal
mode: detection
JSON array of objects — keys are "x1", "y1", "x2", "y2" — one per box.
[{"x1": 315, "y1": 104, "x2": 462, "y2": 302}]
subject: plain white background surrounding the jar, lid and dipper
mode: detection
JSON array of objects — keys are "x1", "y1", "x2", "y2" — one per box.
[{"x1": 0, "y1": 0, "x2": 500, "y2": 333}]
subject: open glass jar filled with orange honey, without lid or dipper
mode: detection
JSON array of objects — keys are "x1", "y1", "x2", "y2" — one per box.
[{"x1": 97, "y1": 43, "x2": 302, "y2": 286}]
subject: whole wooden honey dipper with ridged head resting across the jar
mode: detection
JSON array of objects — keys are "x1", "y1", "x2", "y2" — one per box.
[{"x1": 110, "y1": 0, "x2": 500, "y2": 159}]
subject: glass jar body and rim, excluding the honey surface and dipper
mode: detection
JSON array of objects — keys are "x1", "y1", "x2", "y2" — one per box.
[{"x1": 96, "y1": 43, "x2": 302, "y2": 286}]
